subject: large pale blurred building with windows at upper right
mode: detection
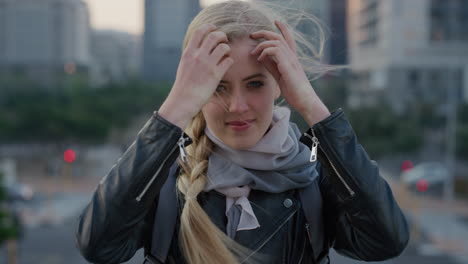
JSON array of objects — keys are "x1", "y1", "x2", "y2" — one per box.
[{"x1": 348, "y1": 0, "x2": 468, "y2": 112}]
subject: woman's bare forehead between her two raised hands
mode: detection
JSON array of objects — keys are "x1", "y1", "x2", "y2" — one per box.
[{"x1": 223, "y1": 38, "x2": 268, "y2": 81}]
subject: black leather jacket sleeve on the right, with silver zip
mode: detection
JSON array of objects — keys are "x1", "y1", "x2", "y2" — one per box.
[{"x1": 306, "y1": 109, "x2": 409, "y2": 261}]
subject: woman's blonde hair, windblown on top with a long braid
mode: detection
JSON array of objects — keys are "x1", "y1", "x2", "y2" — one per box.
[{"x1": 177, "y1": 0, "x2": 329, "y2": 264}]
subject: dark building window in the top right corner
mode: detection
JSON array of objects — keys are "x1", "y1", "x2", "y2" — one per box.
[{"x1": 429, "y1": 0, "x2": 468, "y2": 42}]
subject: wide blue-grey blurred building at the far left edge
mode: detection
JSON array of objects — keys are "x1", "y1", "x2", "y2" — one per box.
[{"x1": 0, "y1": 0, "x2": 90, "y2": 87}]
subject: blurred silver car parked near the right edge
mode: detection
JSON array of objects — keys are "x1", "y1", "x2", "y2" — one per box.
[{"x1": 400, "y1": 162, "x2": 449, "y2": 193}]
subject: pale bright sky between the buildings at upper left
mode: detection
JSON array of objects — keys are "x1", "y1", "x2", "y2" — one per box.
[{"x1": 83, "y1": 0, "x2": 227, "y2": 34}]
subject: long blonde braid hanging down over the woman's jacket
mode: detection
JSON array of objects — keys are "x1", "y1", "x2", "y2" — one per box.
[{"x1": 177, "y1": 113, "x2": 242, "y2": 264}]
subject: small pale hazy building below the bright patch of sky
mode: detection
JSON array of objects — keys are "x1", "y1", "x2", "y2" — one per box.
[{"x1": 91, "y1": 30, "x2": 141, "y2": 86}]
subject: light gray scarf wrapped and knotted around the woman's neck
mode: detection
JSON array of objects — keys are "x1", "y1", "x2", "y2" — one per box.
[{"x1": 204, "y1": 107, "x2": 318, "y2": 237}]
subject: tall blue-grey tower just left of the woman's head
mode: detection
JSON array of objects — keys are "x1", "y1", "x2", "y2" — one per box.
[{"x1": 143, "y1": 0, "x2": 200, "y2": 81}]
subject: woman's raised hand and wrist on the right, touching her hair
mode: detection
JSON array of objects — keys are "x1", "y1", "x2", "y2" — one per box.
[{"x1": 250, "y1": 21, "x2": 330, "y2": 124}]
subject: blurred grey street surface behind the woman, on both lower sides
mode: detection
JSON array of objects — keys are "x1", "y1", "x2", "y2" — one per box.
[{"x1": 0, "y1": 166, "x2": 468, "y2": 264}]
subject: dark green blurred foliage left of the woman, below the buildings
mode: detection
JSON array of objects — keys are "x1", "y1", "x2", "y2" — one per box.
[{"x1": 0, "y1": 79, "x2": 170, "y2": 142}]
